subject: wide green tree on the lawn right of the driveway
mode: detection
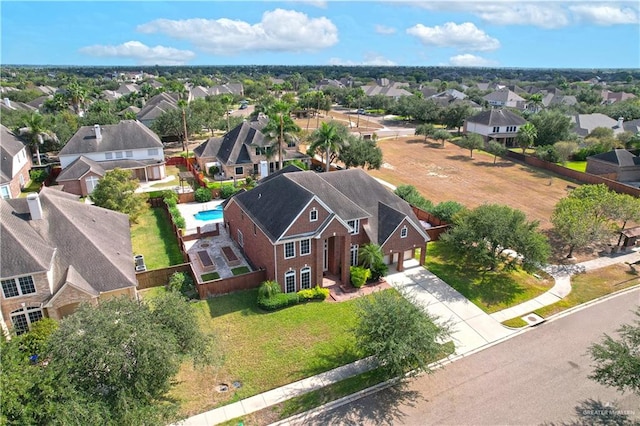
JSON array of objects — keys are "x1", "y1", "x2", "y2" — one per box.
[{"x1": 441, "y1": 204, "x2": 551, "y2": 270}]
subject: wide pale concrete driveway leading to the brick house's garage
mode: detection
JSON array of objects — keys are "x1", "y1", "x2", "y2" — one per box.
[{"x1": 386, "y1": 260, "x2": 517, "y2": 355}]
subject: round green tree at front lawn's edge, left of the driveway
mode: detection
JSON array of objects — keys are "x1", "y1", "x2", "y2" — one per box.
[{"x1": 354, "y1": 290, "x2": 450, "y2": 377}]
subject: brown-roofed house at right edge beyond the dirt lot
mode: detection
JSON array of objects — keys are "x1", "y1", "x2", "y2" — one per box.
[{"x1": 586, "y1": 149, "x2": 640, "y2": 182}]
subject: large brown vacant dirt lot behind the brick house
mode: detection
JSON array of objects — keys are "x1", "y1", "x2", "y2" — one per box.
[{"x1": 370, "y1": 136, "x2": 576, "y2": 229}]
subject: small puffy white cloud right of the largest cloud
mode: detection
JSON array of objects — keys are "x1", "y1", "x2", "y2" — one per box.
[{"x1": 407, "y1": 22, "x2": 500, "y2": 51}]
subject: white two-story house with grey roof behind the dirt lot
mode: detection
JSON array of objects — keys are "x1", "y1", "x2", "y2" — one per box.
[{"x1": 464, "y1": 109, "x2": 527, "y2": 146}]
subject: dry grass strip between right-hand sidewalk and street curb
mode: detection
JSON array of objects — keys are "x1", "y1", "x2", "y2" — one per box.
[{"x1": 534, "y1": 264, "x2": 640, "y2": 318}]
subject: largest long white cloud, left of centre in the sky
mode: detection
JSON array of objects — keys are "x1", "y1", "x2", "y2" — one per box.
[{"x1": 138, "y1": 9, "x2": 338, "y2": 55}]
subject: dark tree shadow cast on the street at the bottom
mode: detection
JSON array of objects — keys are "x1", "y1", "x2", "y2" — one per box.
[{"x1": 305, "y1": 382, "x2": 428, "y2": 425}]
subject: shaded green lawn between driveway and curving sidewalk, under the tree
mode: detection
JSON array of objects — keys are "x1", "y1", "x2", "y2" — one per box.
[{"x1": 426, "y1": 241, "x2": 553, "y2": 313}]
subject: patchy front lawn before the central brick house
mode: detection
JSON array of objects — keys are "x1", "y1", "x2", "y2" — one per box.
[{"x1": 169, "y1": 290, "x2": 380, "y2": 416}]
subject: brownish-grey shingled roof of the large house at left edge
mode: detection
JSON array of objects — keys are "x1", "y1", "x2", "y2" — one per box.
[{"x1": 0, "y1": 187, "x2": 137, "y2": 292}]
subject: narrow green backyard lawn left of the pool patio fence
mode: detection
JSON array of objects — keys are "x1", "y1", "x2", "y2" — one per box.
[{"x1": 131, "y1": 208, "x2": 184, "y2": 269}]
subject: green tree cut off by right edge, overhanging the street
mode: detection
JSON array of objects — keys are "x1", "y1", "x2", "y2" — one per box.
[{"x1": 589, "y1": 307, "x2": 640, "y2": 395}]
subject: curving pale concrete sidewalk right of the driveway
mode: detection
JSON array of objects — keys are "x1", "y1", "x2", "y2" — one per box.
[{"x1": 491, "y1": 249, "x2": 640, "y2": 322}]
